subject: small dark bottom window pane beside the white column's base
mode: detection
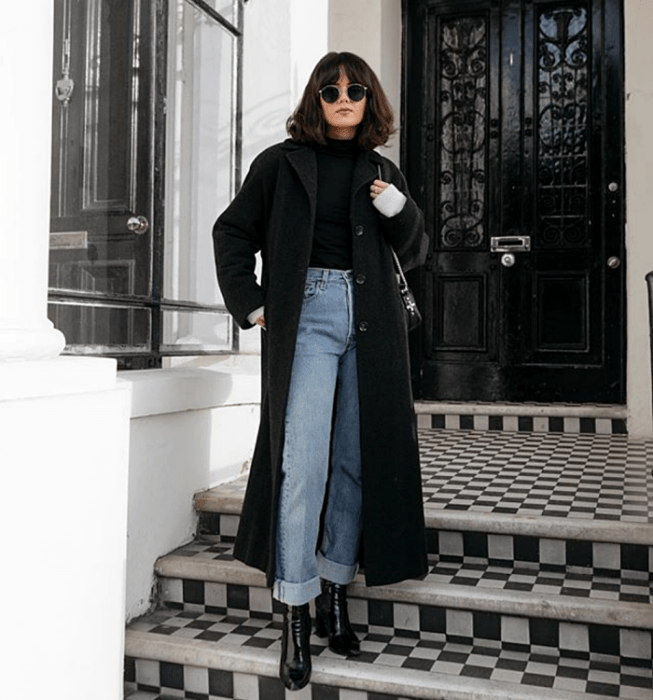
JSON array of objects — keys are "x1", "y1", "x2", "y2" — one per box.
[{"x1": 48, "y1": 302, "x2": 151, "y2": 354}]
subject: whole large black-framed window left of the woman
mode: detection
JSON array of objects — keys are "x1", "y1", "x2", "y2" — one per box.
[{"x1": 49, "y1": 0, "x2": 242, "y2": 368}]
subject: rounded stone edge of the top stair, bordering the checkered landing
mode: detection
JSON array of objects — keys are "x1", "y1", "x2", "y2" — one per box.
[{"x1": 194, "y1": 486, "x2": 653, "y2": 547}]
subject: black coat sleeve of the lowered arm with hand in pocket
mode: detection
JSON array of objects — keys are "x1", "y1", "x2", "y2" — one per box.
[{"x1": 213, "y1": 150, "x2": 276, "y2": 329}]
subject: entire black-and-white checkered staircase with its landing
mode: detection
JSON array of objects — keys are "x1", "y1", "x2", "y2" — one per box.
[{"x1": 125, "y1": 410, "x2": 653, "y2": 700}]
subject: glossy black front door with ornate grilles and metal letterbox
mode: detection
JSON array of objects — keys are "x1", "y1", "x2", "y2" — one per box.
[{"x1": 405, "y1": 0, "x2": 625, "y2": 403}]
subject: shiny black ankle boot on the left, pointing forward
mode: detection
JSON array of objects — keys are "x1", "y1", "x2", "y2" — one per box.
[{"x1": 279, "y1": 603, "x2": 311, "y2": 690}]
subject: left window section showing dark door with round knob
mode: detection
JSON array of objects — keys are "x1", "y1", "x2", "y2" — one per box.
[{"x1": 49, "y1": 0, "x2": 153, "y2": 352}]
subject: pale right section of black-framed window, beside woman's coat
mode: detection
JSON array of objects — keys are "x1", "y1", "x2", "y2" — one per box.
[{"x1": 162, "y1": 0, "x2": 240, "y2": 354}]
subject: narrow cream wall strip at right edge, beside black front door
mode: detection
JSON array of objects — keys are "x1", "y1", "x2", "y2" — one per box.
[{"x1": 624, "y1": 0, "x2": 653, "y2": 437}]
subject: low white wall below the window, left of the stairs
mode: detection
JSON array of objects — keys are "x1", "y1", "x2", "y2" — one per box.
[{"x1": 120, "y1": 358, "x2": 260, "y2": 620}]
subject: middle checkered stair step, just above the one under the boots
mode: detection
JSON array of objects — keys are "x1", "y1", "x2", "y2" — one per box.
[{"x1": 156, "y1": 542, "x2": 653, "y2": 659}]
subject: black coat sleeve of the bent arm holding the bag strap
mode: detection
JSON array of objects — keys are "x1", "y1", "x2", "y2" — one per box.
[{"x1": 379, "y1": 160, "x2": 429, "y2": 271}]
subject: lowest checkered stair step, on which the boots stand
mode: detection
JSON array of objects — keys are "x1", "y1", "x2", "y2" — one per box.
[{"x1": 126, "y1": 610, "x2": 651, "y2": 700}]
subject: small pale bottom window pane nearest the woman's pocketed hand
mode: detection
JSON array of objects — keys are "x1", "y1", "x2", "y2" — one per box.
[{"x1": 163, "y1": 311, "x2": 232, "y2": 352}]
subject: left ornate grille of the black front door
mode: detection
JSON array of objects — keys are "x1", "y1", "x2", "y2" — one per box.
[{"x1": 439, "y1": 16, "x2": 488, "y2": 248}]
